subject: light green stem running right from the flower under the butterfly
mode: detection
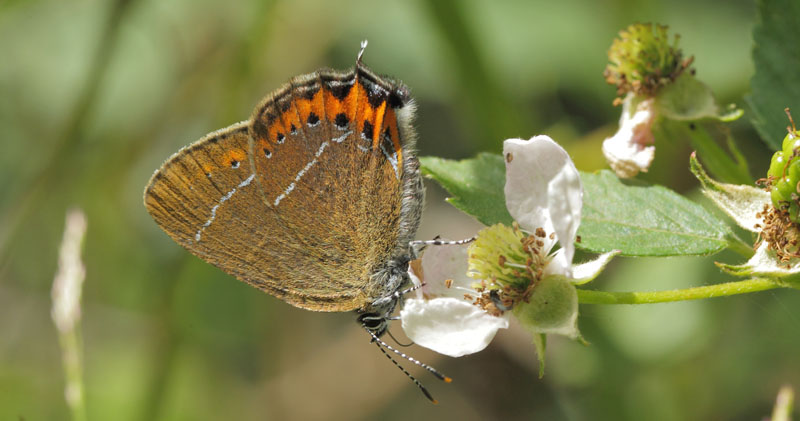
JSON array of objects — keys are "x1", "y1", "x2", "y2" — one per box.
[{"x1": 578, "y1": 278, "x2": 794, "y2": 304}]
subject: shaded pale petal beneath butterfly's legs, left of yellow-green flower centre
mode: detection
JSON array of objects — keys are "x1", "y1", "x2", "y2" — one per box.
[{"x1": 409, "y1": 241, "x2": 475, "y2": 298}]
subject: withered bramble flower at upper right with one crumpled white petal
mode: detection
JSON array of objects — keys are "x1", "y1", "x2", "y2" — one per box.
[{"x1": 603, "y1": 23, "x2": 742, "y2": 178}]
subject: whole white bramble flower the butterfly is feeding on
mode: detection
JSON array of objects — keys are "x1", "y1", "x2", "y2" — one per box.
[{"x1": 400, "y1": 136, "x2": 615, "y2": 357}]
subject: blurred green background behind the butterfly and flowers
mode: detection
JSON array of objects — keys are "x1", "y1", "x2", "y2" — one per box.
[{"x1": 0, "y1": 0, "x2": 800, "y2": 420}]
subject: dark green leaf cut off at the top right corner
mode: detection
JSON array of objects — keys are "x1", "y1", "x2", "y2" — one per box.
[{"x1": 747, "y1": 0, "x2": 800, "y2": 150}]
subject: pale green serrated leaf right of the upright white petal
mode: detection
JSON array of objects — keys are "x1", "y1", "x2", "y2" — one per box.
[{"x1": 576, "y1": 170, "x2": 730, "y2": 256}]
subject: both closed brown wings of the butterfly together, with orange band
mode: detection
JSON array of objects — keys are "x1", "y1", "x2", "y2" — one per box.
[{"x1": 145, "y1": 65, "x2": 418, "y2": 311}]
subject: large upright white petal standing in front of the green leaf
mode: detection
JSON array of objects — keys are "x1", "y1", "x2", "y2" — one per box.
[{"x1": 503, "y1": 136, "x2": 583, "y2": 270}]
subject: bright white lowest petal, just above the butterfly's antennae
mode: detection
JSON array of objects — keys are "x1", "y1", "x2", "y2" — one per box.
[{"x1": 400, "y1": 297, "x2": 508, "y2": 357}]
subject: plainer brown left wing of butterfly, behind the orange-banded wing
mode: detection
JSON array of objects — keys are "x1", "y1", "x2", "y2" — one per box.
[{"x1": 145, "y1": 122, "x2": 301, "y2": 297}]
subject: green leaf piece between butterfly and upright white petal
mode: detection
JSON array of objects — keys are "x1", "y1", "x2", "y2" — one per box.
[{"x1": 420, "y1": 153, "x2": 512, "y2": 225}]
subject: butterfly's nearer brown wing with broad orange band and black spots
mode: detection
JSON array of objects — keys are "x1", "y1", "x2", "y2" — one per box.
[{"x1": 251, "y1": 66, "x2": 410, "y2": 310}]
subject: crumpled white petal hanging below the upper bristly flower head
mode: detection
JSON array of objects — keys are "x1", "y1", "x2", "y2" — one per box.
[{"x1": 603, "y1": 95, "x2": 656, "y2": 178}]
